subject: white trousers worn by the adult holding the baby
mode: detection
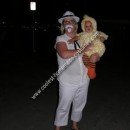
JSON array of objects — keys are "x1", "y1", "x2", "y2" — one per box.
[{"x1": 54, "y1": 80, "x2": 89, "y2": 126}]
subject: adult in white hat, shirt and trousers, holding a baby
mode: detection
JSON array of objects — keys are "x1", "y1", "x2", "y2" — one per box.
[{"x1": 54, "y1": 11, "x2": 91, "y2": 130}]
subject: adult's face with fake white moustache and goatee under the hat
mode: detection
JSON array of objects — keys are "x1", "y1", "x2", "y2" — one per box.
[{"x1": 63, "y1": 18, "x2": 76, "y2": 33}]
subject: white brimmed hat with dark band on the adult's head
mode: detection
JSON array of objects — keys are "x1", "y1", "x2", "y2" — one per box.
[{"x1": 58, "y1": 11, "x2": 80, "y2": 24}]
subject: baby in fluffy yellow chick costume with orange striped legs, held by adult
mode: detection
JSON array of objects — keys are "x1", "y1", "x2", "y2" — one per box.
[{"x1": 78, "y1": 15, "x2": 108, "y2": 79}]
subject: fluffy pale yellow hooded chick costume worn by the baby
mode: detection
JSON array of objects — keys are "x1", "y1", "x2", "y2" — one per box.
[{"x1": 78, "y1": 15, "x2": 108, "y2": 57}]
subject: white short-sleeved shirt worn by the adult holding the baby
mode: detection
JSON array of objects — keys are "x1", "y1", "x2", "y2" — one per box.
[{"x1": 55, "y1": 34, "x2": 88, "y2": 86}]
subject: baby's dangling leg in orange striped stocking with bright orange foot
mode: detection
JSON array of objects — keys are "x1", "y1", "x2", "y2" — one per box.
[{"x1": 82, "y1": 54, "x2": 96, "y2": 79}]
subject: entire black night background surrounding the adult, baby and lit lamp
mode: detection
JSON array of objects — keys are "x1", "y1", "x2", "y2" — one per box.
[{"x1": 0, "y1": 0, "x2": 130, "y2": 130}]
